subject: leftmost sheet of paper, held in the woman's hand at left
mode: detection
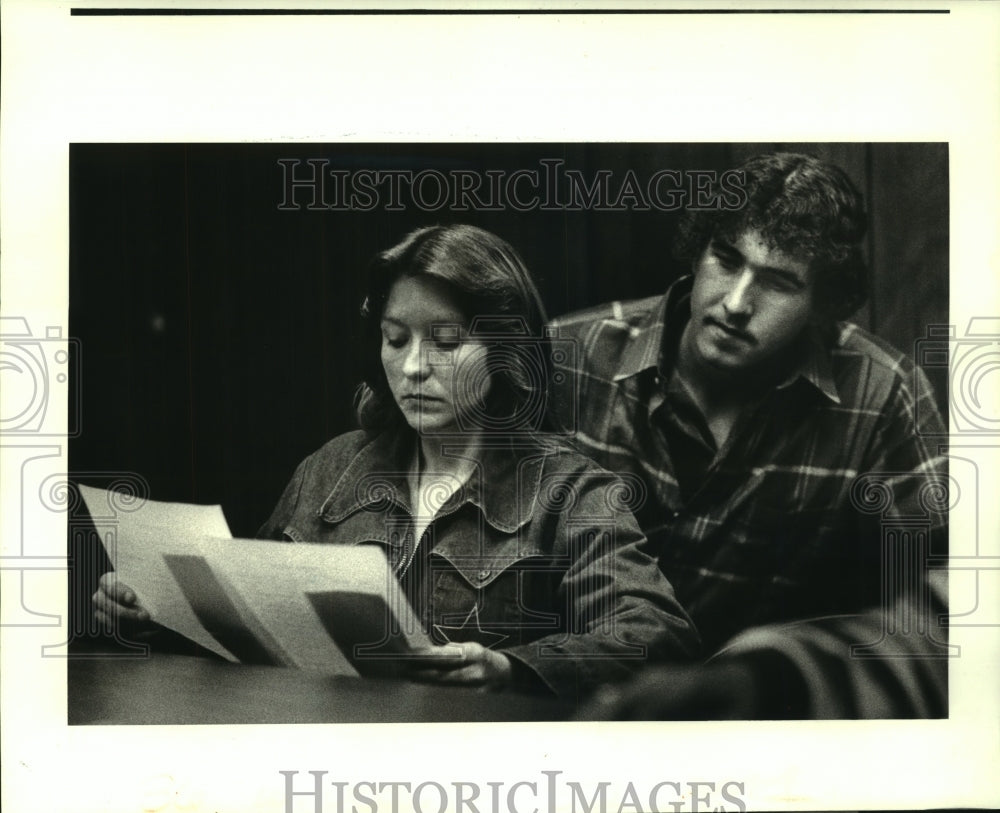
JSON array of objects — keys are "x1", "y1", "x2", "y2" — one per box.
[{"x1": 79, "y1": 485, "x2": 238, "y2": 662}]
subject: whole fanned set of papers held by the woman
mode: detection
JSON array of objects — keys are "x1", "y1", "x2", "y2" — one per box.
[{"x1": 80, "y1": 486, "x2": 430, "y2": 676}]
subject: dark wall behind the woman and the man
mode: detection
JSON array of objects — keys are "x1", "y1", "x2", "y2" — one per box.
[{"x1": 69, "y1": 144, "x2": 948, "y2": 536}]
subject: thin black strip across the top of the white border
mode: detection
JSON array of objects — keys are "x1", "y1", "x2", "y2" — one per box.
[{"x1": 69, "y1": 8, "x2": 951, "y2": 17}]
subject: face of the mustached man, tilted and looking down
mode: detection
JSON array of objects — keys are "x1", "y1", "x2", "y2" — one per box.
[{"x1": 681, "y1": 229, "x2": 814, "y2": 376}]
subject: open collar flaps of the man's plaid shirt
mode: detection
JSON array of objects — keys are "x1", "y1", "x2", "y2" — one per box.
[{"x1": 614, "y1": 274, "x2": 840, "y2": 404}]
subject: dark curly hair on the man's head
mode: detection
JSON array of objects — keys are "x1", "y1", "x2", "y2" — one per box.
[{"x1": 674, "y1": 152, "x2": 868, "y2": 320}]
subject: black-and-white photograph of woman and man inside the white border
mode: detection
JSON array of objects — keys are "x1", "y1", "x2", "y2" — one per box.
[{"x1": 69, "y1": 144, "x2": 948, "y2": 723}]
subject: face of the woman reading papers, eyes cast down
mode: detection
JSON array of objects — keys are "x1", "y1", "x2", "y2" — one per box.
[{"x1": 382, "y1": 275, "x2": 490, "y2": 434}]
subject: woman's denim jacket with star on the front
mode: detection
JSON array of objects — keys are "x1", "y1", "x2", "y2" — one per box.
[{"x1": 259, "y1": 432, "x2": 699, "y2": 696}]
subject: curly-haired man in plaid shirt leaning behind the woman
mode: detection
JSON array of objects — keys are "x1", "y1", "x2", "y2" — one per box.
[{"x1": 555, "y1": 153, "x2": 947, "y2": 717}]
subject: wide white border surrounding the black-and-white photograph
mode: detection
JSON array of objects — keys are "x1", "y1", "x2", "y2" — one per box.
[{"x1": 0, "y1": 0, "x2": 1000, "y2": 813}]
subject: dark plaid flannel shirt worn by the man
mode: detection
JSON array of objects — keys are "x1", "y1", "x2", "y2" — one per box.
[{"x1": 553, "y1": 277, "x2": 947, "y2": 676}]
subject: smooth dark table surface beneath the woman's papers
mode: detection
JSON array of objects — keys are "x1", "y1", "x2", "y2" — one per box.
[{"x1": 68, "y1": 653, "x2": 572, "y2": 725}]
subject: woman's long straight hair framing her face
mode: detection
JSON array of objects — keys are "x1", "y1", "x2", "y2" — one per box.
[{"x1": 355, "y1": 225, "x2": 551, "y2": 434}]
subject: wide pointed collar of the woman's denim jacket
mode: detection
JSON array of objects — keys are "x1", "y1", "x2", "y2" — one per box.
[{"x1": 319, "y1": 430, "x2": 546, "y2": 533}]
